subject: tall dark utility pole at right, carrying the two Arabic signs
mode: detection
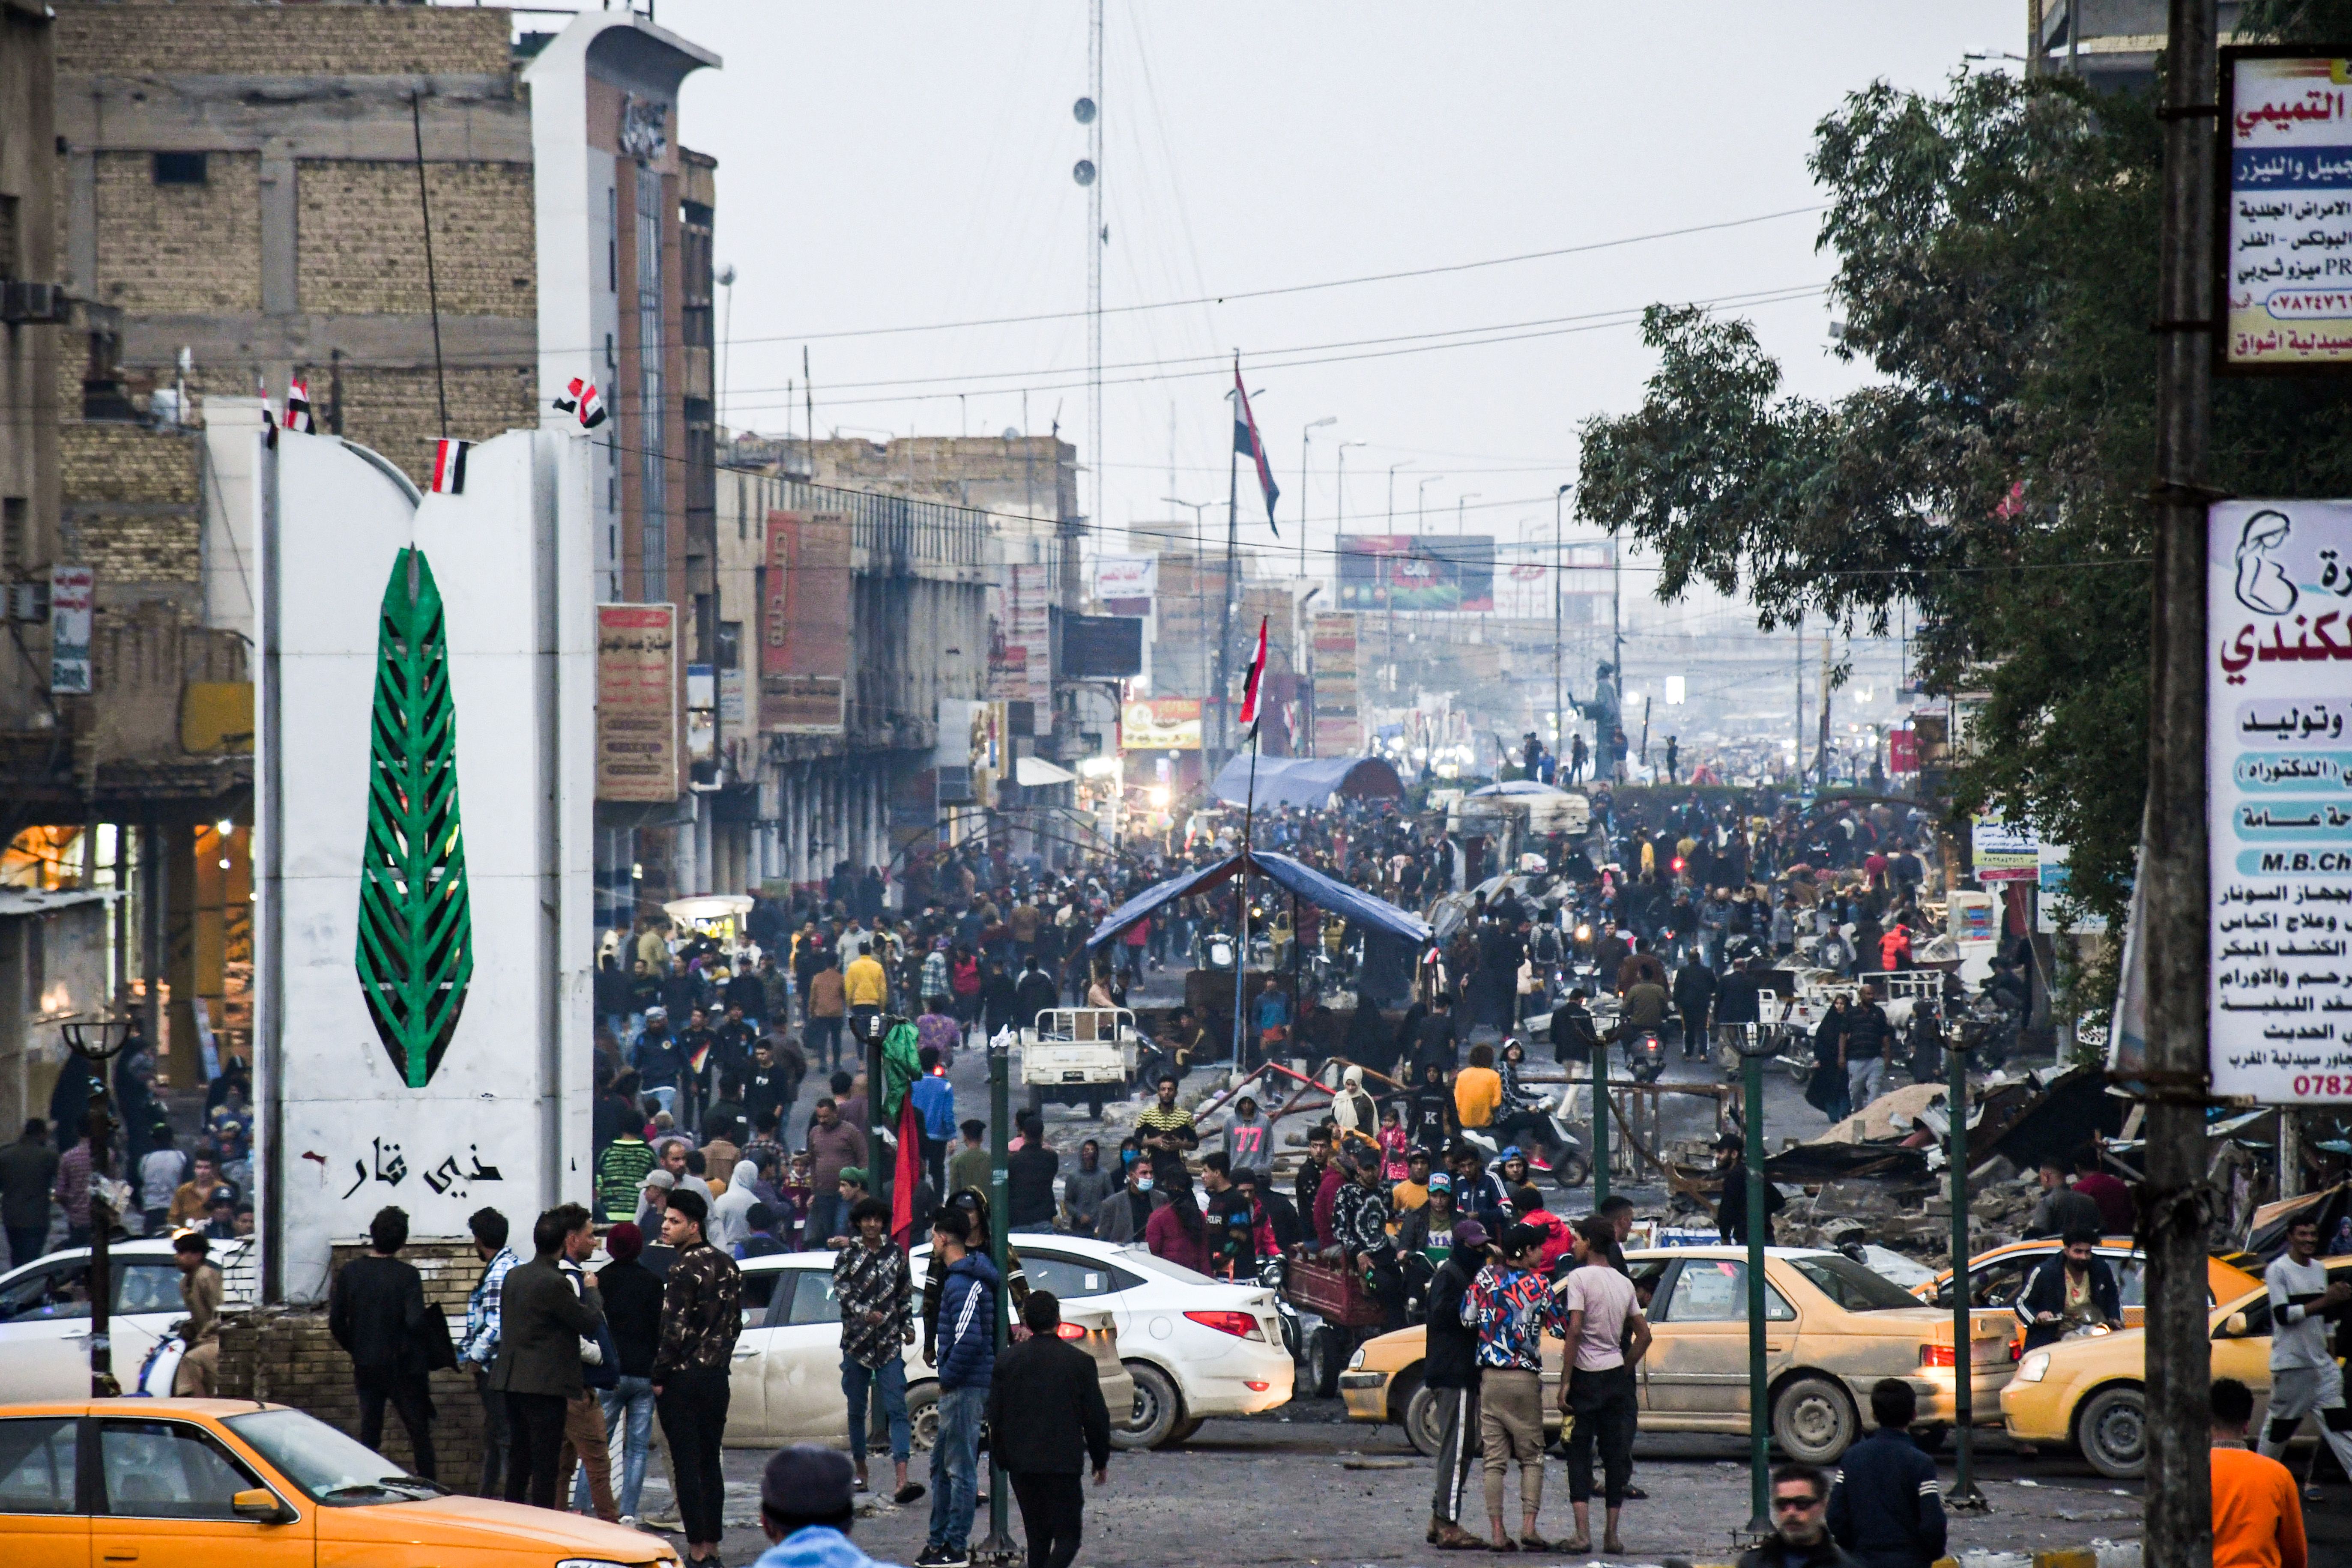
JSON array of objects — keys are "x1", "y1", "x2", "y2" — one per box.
[{"x1": 2145, "y1": 0, "x2": 2218, "y2": 1568}]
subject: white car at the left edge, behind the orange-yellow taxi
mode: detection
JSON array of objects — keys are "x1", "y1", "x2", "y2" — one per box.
[{"x1": 0, "y1": 1236, "x2": 252, "y2": 1404}]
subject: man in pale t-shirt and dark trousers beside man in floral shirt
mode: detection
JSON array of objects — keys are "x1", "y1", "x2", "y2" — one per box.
[{"x1": 1560, "y1": 1216, "x2": 1649, "y2": 1552}]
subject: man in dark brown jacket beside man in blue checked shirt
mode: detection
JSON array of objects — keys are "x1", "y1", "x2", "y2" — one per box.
[{"x1": 489, "y1": 1204, "x2": 604, "y2": 1509}]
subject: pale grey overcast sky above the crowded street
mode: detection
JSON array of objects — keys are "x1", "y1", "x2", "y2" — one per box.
[{"x1": 616, "y1": 0, "x2": 2023, "y2": 738}]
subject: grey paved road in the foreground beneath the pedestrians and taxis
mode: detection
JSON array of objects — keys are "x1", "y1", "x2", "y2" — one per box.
[{"x1": 630, "y1": 1401, "x2": 2201, "y2": 1568}]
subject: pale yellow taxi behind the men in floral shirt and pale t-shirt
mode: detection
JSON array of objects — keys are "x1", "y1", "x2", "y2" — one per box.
[{"x1": 1338, "y1": 1246, "x2": 2011, "y2": 1464}]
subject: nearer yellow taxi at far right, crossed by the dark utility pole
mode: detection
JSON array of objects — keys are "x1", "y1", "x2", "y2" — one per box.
[{"x1": 2002, "y1": 1255, "x2": 2352, "y2": 1478}]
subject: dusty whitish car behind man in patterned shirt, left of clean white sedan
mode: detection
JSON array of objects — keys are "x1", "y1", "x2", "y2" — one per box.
[{"x1": 727, "y1": 1248, "x2": 1136, "y2": 1451}]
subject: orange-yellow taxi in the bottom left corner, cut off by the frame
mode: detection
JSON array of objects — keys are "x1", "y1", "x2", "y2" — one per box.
[{"x1": 0, "y1": 1399, "x2": 677, "y2": 1568}]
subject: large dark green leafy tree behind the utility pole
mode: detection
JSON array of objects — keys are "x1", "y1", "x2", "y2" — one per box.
[{"x1": 1576, "y1": 64, "x2": 2352, "y2": 968}]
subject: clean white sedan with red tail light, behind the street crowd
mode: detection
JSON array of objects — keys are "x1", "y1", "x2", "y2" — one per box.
[{"x1": 915, "y1": 1232, "x2": 1296, "y2": 1448}]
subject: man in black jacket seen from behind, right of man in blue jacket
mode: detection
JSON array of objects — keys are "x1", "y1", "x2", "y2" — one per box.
[{"x1": 988, "y1": 1290, "x2": 1110, "y2": 1568}]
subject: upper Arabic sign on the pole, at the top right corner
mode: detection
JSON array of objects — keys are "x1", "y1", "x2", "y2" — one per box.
[{"x1": 2213, "y1": 49, "x2": 2352, "y2": 371}]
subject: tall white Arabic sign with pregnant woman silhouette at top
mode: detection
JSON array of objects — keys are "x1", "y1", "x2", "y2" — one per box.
[{"x1": 2206, "y1": 501, "x2": 2352, "y2": 1105}]
